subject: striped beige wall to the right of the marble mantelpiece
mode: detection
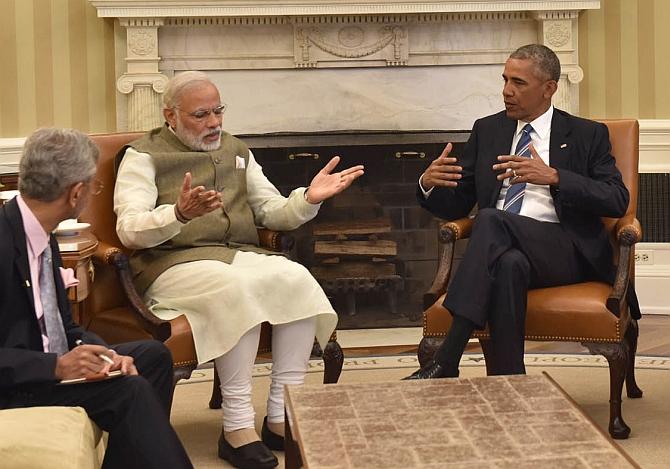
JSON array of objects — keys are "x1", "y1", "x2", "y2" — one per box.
[{"x1": 579, "y1": 0, "x2": 670, "y2": 119}]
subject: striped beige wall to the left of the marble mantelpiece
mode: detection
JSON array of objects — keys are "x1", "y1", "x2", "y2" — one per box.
[{"x1": 0, "y1": 0, "x2": 116, "y2": 137}]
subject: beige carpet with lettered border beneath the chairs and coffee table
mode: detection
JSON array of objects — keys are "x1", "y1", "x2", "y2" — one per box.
[{"x1": 172, "y1": 354, "x2": 670, "y2": 469}]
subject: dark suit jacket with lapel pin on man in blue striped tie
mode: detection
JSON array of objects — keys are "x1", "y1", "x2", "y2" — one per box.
[{"x1": 417, "y1": 109, "x2": 635, "y2": 314}]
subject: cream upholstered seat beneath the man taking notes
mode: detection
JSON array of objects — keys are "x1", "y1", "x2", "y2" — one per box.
[{"x1": 0, "y1": 407, "x2": 104, "y2": 469}]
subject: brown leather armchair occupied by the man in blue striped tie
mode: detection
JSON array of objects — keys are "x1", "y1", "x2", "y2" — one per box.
[{"x1": 419, "y1": 120, "x2": 642, "y2": 439}]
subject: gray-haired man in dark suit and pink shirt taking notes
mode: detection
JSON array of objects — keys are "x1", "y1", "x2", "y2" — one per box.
[{"x1": 0, "y1": 129, "x2": 192, "y2": 469}]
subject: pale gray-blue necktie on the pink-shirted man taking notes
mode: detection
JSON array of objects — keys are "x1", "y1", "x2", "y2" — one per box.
[{"x1": 39, "y1": 244, "x2": 68, "y2": 355}]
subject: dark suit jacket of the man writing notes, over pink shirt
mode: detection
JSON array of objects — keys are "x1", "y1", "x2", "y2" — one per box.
[{"x1": 0, "y1": 199, "x2": 106, "y2": 402}]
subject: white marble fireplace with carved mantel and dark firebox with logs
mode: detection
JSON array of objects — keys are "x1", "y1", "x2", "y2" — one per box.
[{"x1": 90, "y1": 0, "x2": 600, "y2": 328}]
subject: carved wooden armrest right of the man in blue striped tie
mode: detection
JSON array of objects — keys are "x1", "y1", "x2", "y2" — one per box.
[{"x1": 607, "y1": 215, "x2": 642, "y2": 317}]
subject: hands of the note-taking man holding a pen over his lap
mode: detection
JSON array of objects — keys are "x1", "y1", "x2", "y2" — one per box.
[{"x1": 55, "y1": 344, "x2": 137, "y2": 380}]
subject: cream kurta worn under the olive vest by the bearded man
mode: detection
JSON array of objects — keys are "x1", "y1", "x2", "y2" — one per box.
[{"x1": 114, "y1": 148, "x2": 337, "y2": 363}]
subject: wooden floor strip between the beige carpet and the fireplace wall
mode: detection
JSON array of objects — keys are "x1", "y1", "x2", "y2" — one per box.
[{"x1": 344, "y1": 315, "x2": 670, "y2": 358}]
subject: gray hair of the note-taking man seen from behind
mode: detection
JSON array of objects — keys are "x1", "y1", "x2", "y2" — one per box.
[{"x1": 19, "y1": 128, "x2": 100, "y2": 202}]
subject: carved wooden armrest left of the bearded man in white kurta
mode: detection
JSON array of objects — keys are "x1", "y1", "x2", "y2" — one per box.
[{"x1": 93, "y1": 242, "x2": 172, "y2": 342}]
